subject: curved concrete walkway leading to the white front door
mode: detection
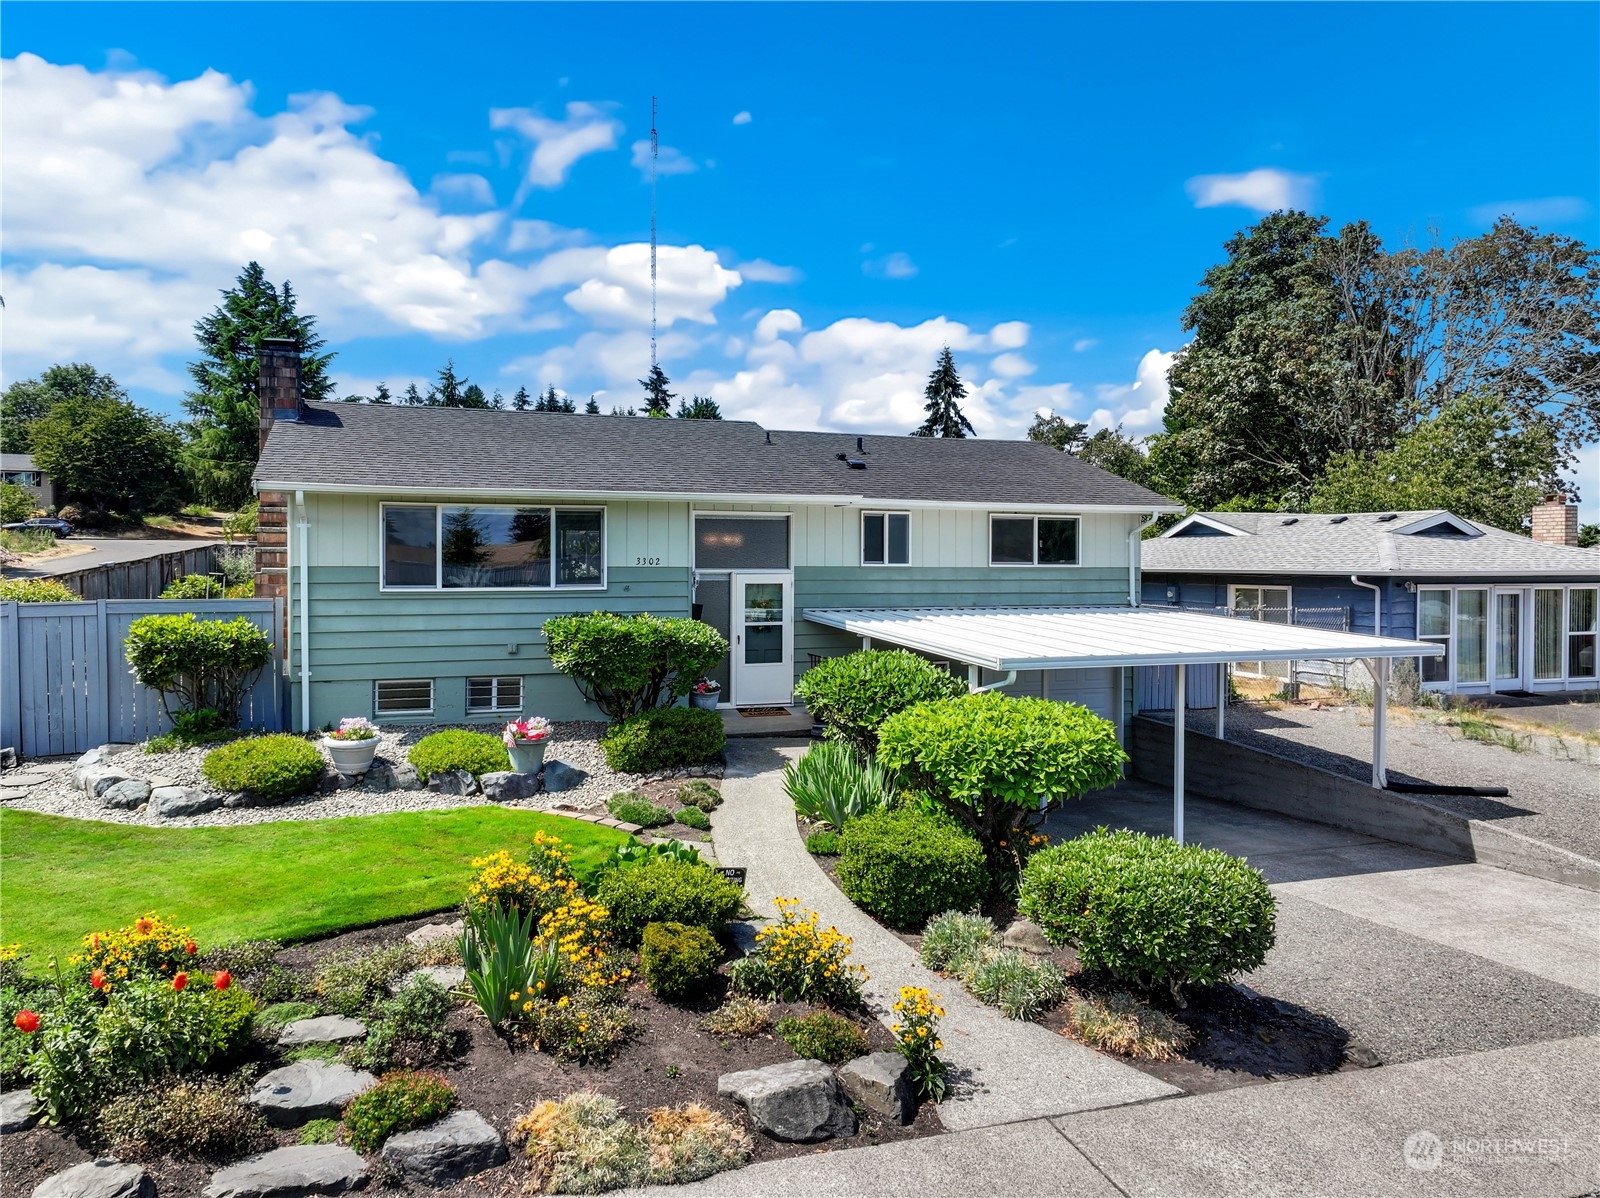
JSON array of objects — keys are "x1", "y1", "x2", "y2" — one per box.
[{"x1": 714, "y1": 741, "x2": 1181, "y2": 1131}]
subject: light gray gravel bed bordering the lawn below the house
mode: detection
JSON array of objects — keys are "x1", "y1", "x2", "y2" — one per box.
[{"x1": 0, "y1": 721, "x2": 720, "y2": 827}]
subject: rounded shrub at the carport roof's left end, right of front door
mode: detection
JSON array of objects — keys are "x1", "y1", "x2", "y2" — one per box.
[{"x1": 795, "y1": 649, "x2": 966, "y2": 757}]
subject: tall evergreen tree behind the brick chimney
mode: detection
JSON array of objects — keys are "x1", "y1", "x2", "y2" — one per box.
[{"x1": 184, "y1": 262, "x2": 333, "y2": 509}]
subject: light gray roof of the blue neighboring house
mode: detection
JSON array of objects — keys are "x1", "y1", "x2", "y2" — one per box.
[{"x1": 1141, "y1": 509, "x2": 1600, "y2": 579}]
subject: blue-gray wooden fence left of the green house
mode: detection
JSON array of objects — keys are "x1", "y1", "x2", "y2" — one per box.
[{"x1": 0, "y1": 598, "x2": 285, "y2": 757}]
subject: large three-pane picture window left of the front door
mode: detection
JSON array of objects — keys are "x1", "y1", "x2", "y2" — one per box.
[{"x1": 382, "y1": 504, "x2": 605, "y2": 590}]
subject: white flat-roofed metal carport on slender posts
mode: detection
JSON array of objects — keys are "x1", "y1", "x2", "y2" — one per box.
[{"x1": 805, "y1": 606, "x2": 1443, "y2": 841}]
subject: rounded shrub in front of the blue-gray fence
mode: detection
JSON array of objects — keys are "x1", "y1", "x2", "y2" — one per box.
[{"x1": 125, "y1": 611, "x2": 272, "y2": 728}]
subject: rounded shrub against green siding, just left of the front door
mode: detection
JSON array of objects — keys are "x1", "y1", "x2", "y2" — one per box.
[{"x1": 544, "y1": 611, "x2": 728, "y2": 716}]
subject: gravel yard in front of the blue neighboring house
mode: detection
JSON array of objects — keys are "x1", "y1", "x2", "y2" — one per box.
[{"x1": 1168, "y1": 704, "x2": 1600, "y2": 861}]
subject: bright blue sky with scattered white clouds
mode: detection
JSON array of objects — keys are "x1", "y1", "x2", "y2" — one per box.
[{"x1": 0, "y1": 3, "x2": 1600, "y2": 518}]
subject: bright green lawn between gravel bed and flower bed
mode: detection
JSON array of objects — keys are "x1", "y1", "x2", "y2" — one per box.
[{"x1": 0, "y1": 806, "x2": 629, "y2": 964}]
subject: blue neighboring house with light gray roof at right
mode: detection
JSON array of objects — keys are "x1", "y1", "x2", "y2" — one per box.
[{"x1": 1142, "y1": 499, "x2": 1600, "y2": 694}]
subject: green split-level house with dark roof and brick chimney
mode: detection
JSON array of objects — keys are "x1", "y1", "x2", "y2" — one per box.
[{"x1": 256, "y1": 355, "x2": 1173, "y2": 728}]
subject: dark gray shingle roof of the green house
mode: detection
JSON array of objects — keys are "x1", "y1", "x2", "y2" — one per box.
[{"x1": 256, "y1": 403, "x2": 1178, "y2": 512}]
